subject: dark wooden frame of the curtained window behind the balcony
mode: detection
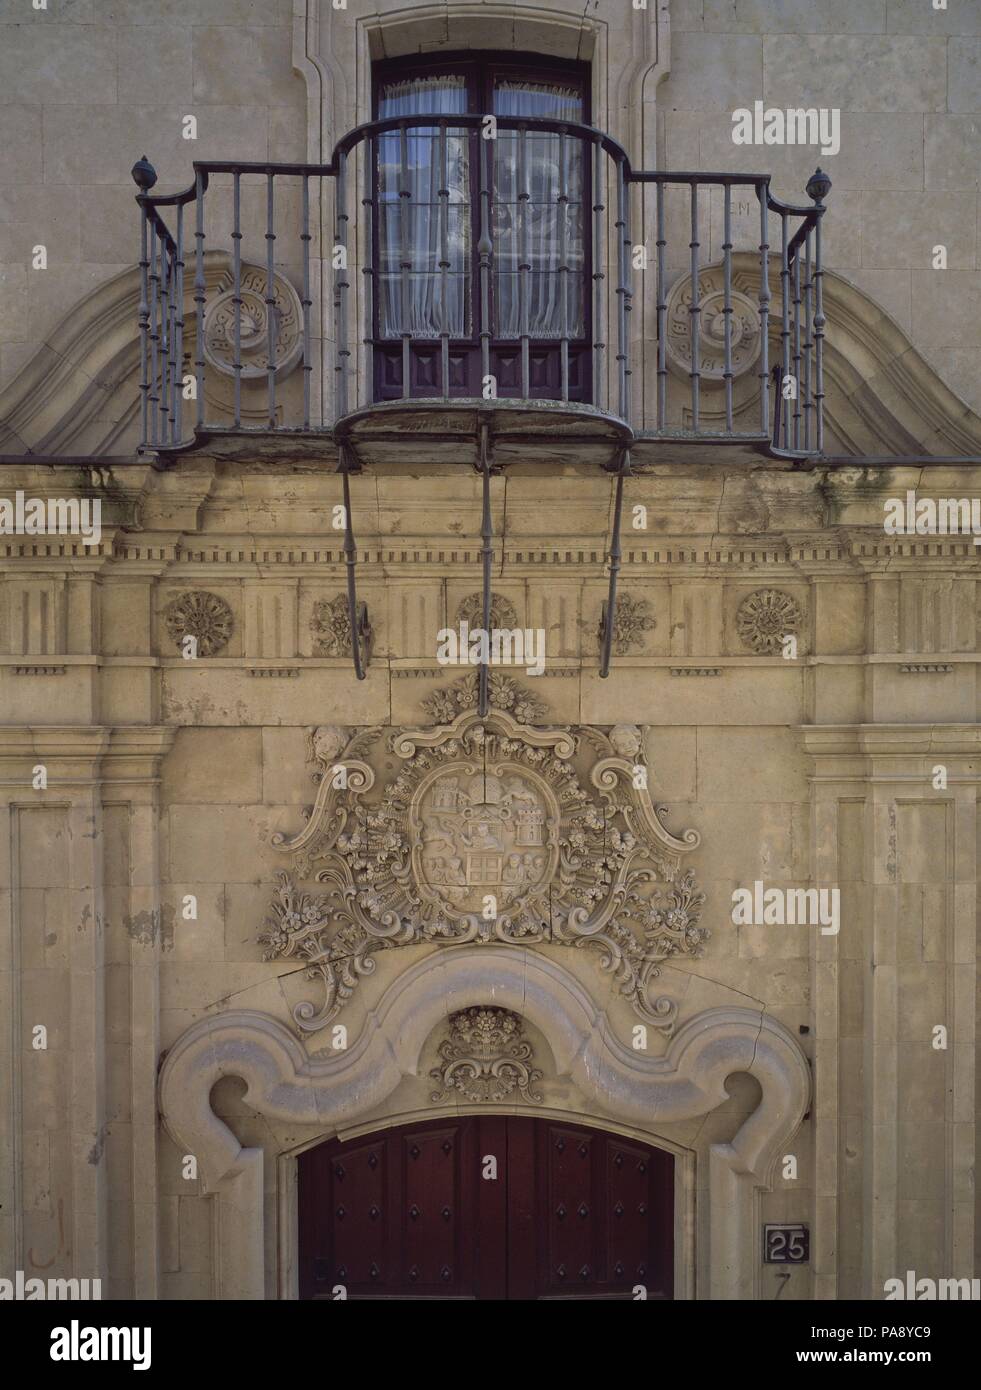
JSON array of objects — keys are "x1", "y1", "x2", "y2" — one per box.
[{"x1": 371, "y1": 50, "x2": 593, "y2": 402}]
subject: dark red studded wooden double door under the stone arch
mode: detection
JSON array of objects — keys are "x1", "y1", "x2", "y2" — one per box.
[{"x1": 299, "y1": 1115, "x2": 674, "y2": 1298}]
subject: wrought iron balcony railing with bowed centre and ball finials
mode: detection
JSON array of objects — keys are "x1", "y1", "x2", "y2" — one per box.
[{"x1": 133, "y1": 114, "x2": 831, "y2": 456}]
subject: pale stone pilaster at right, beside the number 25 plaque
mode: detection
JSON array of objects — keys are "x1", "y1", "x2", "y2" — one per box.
[{"x1": 802, "y1": 724, "x2": 981, "y2": 1298}]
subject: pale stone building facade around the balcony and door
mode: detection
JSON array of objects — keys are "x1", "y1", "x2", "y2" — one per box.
[{"x1": 0, "y1": 0, "x2": 981, "y2": 1300}]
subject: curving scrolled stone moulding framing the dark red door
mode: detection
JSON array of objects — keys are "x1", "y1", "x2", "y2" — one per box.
[{"x1": 160, "y1": 945, "x2": 810, "y2": 1298}]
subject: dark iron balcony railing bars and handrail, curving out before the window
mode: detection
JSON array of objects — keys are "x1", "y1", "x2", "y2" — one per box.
[{"x1": 133, "y1": 114, "x2": 831, "y2": 455}]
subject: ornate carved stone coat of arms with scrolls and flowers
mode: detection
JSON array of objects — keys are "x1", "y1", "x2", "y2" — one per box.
[{"x1": 260, "y1": 709, "x2": 709, "y2": 1033}]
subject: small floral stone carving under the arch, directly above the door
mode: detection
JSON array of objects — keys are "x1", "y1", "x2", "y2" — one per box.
[{"x1": 429, "y1": 1005, "x2": 542, "y2": 1105}]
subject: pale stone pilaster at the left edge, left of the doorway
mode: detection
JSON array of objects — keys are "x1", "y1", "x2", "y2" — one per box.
[{"x1": 0, "y1": 726, "x2": 172, "y2": 1297}]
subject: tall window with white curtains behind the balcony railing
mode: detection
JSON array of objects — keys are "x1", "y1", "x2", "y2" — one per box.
[{"x1": 374, "y1": 56, "x2": 591, "y2": 400}]
